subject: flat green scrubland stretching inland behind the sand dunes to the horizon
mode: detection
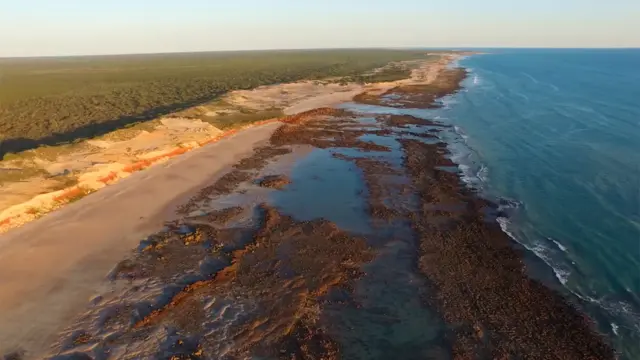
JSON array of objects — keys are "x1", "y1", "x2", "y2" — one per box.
[{"x1": 0, "y1": 50, "x2": 424, "y2": 157}]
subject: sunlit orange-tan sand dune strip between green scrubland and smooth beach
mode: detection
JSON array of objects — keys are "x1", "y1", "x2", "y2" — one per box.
[{"x1": 0, "y1": 53, "x2": 464, "y2": 234}]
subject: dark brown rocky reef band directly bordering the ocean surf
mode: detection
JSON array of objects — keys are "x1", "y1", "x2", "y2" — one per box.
[{"x1": 350, "y1": 60, "x2": 615, "y2": 359}]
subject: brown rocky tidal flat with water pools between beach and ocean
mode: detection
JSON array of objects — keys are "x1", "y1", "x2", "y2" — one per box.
[{"x1": 2, "y1": 57, "x2": 614, "y2": 359}]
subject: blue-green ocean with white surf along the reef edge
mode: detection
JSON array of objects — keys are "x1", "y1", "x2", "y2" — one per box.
[{"x1": 432, "y1": 49, "x2": 640, "y2": 359}]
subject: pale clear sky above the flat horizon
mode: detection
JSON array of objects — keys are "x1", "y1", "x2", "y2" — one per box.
[{"x1": 0, "y1": 0, "x2": 640, "y2": 56}]
